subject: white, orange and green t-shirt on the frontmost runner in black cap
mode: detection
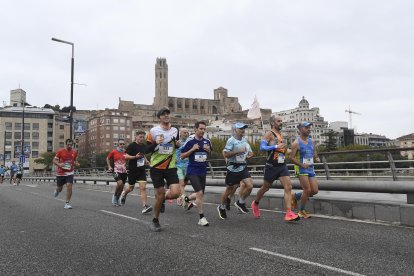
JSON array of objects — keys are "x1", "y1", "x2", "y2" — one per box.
[{"x1": 147, "y1": 126, "x2": 179, "y2": 170}]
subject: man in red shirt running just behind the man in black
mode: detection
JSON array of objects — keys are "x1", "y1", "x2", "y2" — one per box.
[{"x1": 106, "y1": 139, "x2": 128, "y2": 206}]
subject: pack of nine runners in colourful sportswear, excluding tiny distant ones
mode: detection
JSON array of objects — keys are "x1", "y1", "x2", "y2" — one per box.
[{"x1": 49, "y1": 107, "x2": 319, "y2": 232}]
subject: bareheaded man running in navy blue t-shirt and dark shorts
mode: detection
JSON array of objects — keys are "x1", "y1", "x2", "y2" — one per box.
[{"x1": 181, "y1": 121, "x2": 212, "y2": 226}]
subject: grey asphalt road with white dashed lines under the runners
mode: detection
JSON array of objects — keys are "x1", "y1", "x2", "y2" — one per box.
[{"x1": 0, "y1": 183, "x2": 414, "y2": 275}]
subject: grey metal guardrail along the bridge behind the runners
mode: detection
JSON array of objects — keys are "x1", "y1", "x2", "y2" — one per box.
[{"x1": 25, "y1": 147, "x2": 414, "y2": 204}]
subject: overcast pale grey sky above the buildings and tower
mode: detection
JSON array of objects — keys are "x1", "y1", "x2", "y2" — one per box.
[{"x1": 0, "y1": 0, "x2": 414, "y2": 138}]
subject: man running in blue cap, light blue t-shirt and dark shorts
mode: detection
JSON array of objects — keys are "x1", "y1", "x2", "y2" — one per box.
[{"x1": 217, "y1": 123, "x2": 253, "y2": 219}]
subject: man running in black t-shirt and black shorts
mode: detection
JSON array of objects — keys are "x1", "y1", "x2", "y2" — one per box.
[{"x1": 121, "y1": 130, "x2": 152, "y2": 214}]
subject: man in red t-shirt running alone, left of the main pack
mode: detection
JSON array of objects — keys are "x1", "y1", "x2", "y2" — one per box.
[{"x1": 53, "y1": 139, "x2": 79, "y2": 209}]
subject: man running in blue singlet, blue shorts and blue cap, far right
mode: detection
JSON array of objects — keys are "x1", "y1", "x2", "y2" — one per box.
[{"x1": 290, "y1": 122, "x2": 320, "y2": 218}]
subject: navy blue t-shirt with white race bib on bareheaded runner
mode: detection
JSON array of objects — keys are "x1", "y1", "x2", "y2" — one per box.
[{"x1": 181, "y1": 137, "x2": 212, "y2": 175}]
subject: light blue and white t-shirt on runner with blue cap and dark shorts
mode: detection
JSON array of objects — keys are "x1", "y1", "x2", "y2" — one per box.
[{"x1": 224, "y1": 136, "x2": 252, "y2": 172}]
